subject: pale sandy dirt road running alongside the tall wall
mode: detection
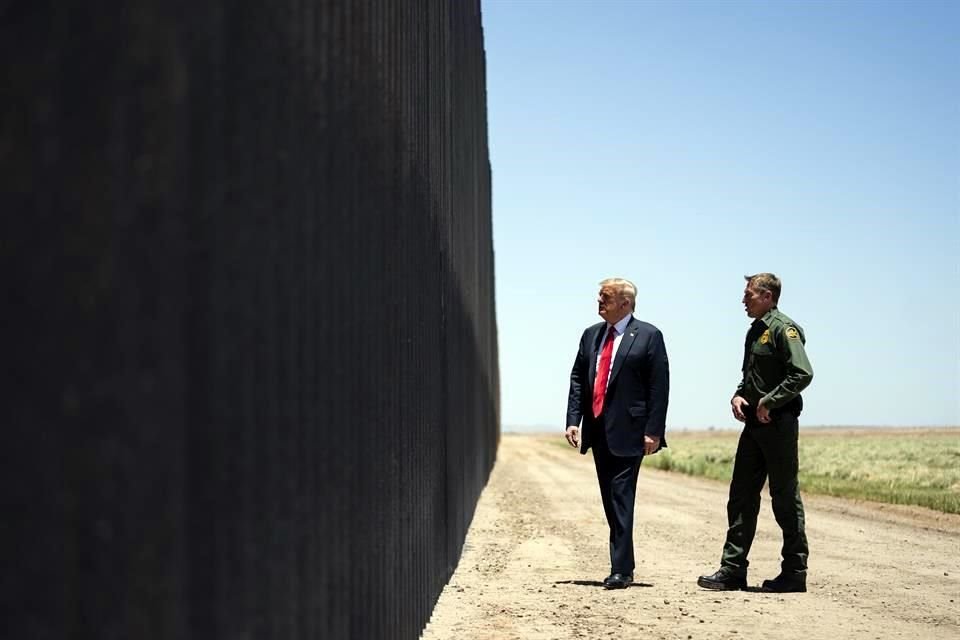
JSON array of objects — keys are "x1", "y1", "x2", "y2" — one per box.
[{"x1": 423, "y1": 434, "x2": 960, "y2": 640}]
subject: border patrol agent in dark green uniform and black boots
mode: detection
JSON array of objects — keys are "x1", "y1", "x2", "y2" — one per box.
[{"x1": 697, "y1": 273, "x2": 813, "y2": 593}]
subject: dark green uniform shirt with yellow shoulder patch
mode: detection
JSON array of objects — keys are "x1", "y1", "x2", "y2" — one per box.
[{"x1": 736, "y1": 307, "x2": 813, "y2": 409}]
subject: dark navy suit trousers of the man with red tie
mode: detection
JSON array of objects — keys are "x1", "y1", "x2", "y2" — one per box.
[{"x1": 591, "y1": 421, "x2": 643, "y2": 575}]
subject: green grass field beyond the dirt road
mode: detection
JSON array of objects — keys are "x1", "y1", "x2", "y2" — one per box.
[{"x1": 644, "y1": 428, "x2": 960, "y2": 513}]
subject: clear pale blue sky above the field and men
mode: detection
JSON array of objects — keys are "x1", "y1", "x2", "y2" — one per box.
[{"x1": 482, "y1": 0, "x2": 960, "y2": 430}]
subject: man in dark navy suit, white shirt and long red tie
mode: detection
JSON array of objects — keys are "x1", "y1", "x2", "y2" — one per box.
[{"x1": 566, "y1": 278, "x2": 670, "y2": 589}]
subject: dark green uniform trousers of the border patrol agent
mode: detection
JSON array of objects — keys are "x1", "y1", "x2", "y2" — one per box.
[{"x1": 720, "y1": 413, "x2": 809, "y2": 575}]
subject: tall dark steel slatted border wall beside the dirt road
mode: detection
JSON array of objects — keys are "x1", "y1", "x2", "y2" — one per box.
[{"x1": 0, "y1": 0, "x2": 499, "y2": 640}]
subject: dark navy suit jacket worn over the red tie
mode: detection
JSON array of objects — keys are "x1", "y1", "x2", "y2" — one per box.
[{"x1": 567, "y1": 316, "x2": 670, "y2": 456}]
